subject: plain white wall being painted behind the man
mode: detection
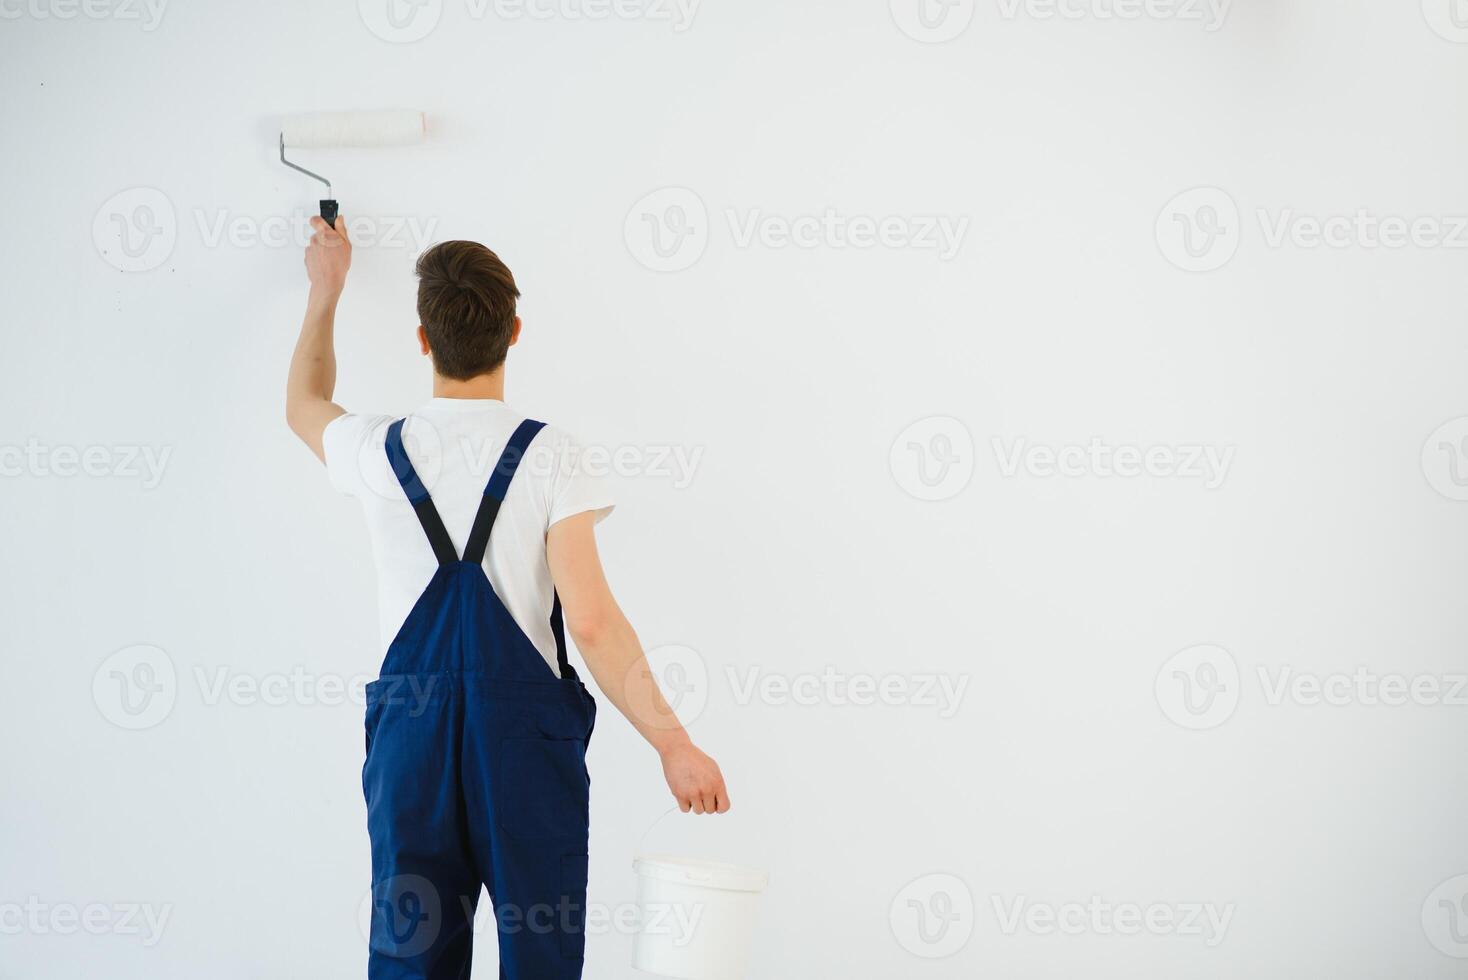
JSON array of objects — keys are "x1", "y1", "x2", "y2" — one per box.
[{"x1": 0, "y1": 0, "x2": 1468, "y2": 980}]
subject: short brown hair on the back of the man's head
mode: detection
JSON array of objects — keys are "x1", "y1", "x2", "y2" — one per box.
[{"x1": 417, "y1": 242, "x2": 520, "y2": 381}]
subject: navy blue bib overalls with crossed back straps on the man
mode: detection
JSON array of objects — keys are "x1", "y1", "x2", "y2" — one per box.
[{"x1": 363, "y1": 420, "x2": 596, "y2": 980}]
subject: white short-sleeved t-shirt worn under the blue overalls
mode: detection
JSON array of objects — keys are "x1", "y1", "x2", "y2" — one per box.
[{"x1": 321, "y1": 398, "x2": 612, "y2": 670}]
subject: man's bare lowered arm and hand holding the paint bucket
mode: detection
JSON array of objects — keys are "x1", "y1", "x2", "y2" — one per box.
[{"x1": 546, "y1": 512, "x2": 730, "y2": 813}]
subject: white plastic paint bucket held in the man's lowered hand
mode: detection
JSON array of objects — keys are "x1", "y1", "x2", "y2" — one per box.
[{"x1": 633, "y1": 854, "x2": 769, "y2": 980}]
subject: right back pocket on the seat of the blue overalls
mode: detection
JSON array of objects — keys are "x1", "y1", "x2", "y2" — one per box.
[{"x1": 495, "y1": 738, "x2": 590, "y2": 841}]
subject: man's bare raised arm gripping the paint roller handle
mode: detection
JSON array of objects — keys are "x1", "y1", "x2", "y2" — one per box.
[{"x1": 285, "y1": 217, "x2": 352, "y2": 461}]
